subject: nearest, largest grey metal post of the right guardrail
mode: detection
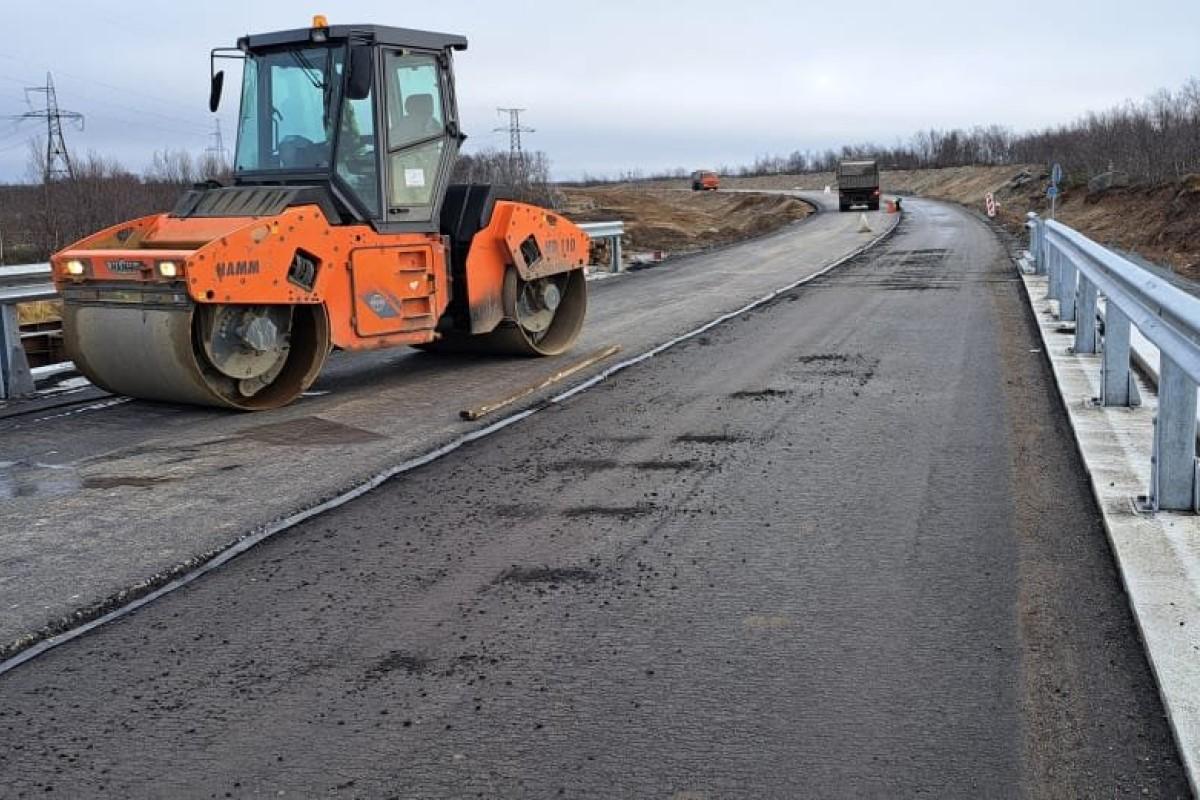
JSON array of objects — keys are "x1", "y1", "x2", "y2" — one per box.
[{"x1": 1150, "y1": 351, "x2": 1196, "y2": 511}]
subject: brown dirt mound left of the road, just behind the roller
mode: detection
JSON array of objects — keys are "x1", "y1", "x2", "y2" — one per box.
[{"x1": 562, "y1": 184, "x2": 812, "y2": 253}]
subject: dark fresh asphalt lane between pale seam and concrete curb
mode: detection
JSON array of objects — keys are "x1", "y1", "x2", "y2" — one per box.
[{"x1": 0, "y1": 203, "x2": 1188, "y2": 800}]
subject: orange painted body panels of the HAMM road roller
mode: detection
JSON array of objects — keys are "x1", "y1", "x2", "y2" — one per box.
[{"x1": 52, "y1": 200, "x2": 588, "y2": 350}]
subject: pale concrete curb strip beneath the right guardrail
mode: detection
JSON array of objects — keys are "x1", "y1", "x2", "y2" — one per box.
[{"x1": 1021, "y1": 273, "x2": 1200, "y2": 796}]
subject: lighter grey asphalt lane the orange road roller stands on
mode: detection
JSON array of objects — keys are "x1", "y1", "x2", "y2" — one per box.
[{"x1": 0, "y1": 193, "x2": 894, "y2": 655}]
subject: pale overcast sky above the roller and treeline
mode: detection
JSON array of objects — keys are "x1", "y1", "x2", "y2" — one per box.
[{"x1": 0, "y1": 0, "x2": 1200, "y2": 180}]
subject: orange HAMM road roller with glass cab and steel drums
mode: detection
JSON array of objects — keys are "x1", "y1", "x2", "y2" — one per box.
[{"x1": 52, "y1": 17, "x2": 588, "y2": 410}]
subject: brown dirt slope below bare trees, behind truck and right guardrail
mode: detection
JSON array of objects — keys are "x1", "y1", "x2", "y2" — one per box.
[{"x1": 724, "y1": 164, "x2": 1200, "y2": 279}]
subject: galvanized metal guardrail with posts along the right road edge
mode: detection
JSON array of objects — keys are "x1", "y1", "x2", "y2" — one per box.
[{"x1": 1026, "y1": 212, "x2": 1200, "y2": 511}]
